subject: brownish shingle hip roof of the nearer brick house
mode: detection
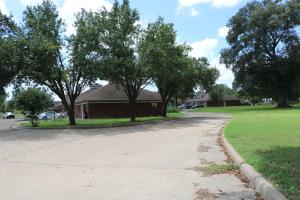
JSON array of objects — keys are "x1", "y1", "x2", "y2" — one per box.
[{"x1": 76, "y1": 83, "x2": 161, "y2": 103}]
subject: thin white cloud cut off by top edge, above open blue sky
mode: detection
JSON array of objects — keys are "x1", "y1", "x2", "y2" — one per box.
[{"x1": 178, "y1": 0, "x2": 241, "y2": 8}]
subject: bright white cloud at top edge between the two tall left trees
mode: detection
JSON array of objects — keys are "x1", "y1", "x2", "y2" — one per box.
[{"x1": 59, "y1": 0, "x2": 112, "y2": 34}]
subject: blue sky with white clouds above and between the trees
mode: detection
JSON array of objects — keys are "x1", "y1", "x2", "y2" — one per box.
[{"x1": 0, "y1": 0, "x2": 249, "y2": 94}]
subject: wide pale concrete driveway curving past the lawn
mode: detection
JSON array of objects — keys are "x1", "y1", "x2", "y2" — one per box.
[{"x1": 0, "y1": 113, "x2": 255, "y2": 200}]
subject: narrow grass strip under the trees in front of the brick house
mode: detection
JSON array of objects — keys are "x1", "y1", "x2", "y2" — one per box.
[{"x1": 20, "y1": 113, "x2": 183, "y2": 128}]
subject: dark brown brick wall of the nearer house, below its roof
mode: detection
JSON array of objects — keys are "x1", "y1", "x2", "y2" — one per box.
[{"x1": 75, "y1": 103, "x2": 162, "y2": 118}]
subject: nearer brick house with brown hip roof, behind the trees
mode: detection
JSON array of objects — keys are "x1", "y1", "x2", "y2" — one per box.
[{"x1": 75, "y1": 83, "x2": 162, "y2": 118}]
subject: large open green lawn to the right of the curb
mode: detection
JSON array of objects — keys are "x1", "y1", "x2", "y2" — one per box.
[{"x1": 195, "y1": 105, "x2": 300, "y2": 199}]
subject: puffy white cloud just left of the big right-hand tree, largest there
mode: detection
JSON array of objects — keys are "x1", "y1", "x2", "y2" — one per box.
[{"x1": 190, "y1": 38, "x2": 219, "y2": 58}]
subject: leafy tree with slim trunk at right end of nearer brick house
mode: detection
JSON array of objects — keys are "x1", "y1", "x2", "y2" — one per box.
[{"x1": 139, "y1": 17, "x2": 189, "y2": 117}]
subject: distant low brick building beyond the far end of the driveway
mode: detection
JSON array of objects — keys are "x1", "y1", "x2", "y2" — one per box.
[{"x1": 185, "y1": 93, "x2": 241, "y2": 107}]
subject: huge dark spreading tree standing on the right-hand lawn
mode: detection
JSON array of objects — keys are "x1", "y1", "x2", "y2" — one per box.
[{"x1": 221, "y1": 0, "x2": 300, "y2": 107}]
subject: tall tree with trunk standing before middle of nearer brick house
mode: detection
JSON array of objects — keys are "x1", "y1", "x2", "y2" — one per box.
[{"x1": 78, "y1": 0, "x2": 149, "y2": 121}]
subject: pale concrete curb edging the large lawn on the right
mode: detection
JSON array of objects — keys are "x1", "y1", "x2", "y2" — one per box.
[{"x1": 221, "y1": 129, "x2": 287, "y2": 200}]
